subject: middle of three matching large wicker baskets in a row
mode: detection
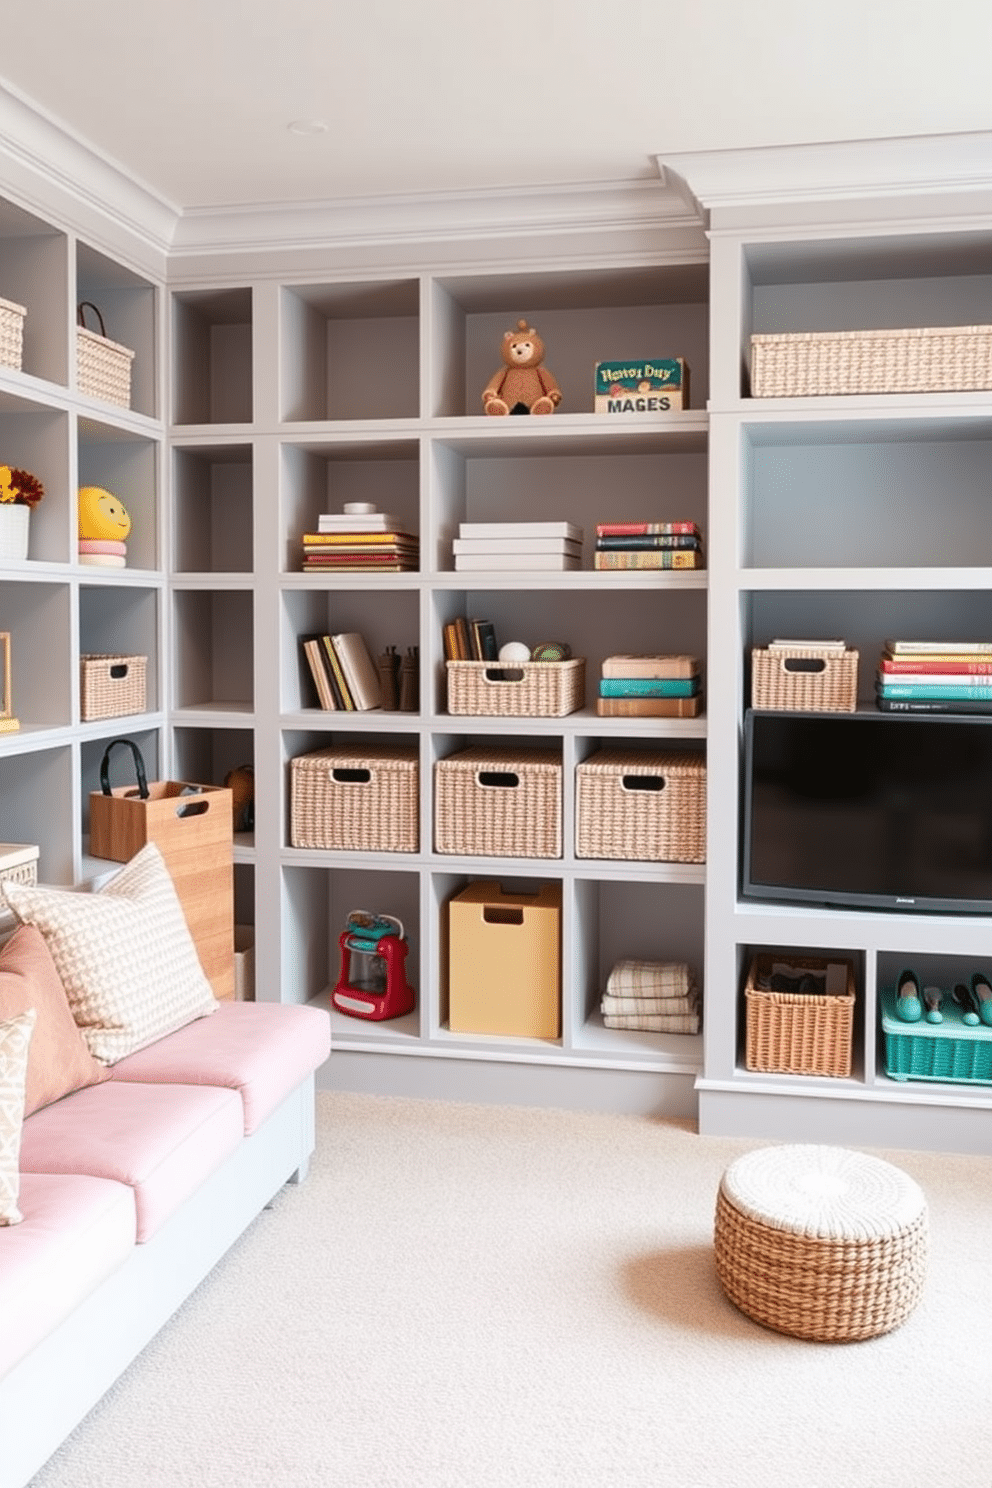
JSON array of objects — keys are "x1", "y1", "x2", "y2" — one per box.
[{"x1": 434, "y1": 745, "x2": 562, "y2": 857}]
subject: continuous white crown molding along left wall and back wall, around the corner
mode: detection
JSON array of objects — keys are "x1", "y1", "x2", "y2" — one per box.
[{"x1": 0, "y1": 79, "x2": 705, "y2": 274}]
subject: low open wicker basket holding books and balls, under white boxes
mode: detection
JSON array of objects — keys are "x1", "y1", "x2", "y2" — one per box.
[{"x1": 446, "y1": 658, "x2": 586, "y2": 719}]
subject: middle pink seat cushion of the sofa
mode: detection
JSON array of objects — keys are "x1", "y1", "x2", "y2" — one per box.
[{"x1": 21, "y1": 1080, "x2": 244, "y2": 1241}]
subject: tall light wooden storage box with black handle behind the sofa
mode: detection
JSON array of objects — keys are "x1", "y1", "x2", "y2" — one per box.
[{"x1": 89, "y1": 740, "x2": 235, "y2": 1000}]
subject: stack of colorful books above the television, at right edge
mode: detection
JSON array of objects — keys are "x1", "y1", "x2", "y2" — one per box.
[{"x1": 875, "y1": 640, "x2": 992, "y2": 713}]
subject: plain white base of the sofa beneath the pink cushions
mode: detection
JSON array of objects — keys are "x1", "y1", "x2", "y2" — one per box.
[{"x1": 0, "y1": 1076, "x2": 315, "y2": 1488}]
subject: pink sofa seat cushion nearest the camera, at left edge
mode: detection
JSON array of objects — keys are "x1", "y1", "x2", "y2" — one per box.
[{"x1": 0, "y1": 1173, "x2": 135, "y2": 1376}]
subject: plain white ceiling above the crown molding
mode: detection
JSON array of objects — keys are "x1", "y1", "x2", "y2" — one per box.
[{"x1": 0, "y1": 0, "x2": 992, "y2": 210}]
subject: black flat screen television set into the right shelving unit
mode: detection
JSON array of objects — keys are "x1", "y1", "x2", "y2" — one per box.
[{"x1": 741, "y1": 710, "x2": 992, "y2": 915}]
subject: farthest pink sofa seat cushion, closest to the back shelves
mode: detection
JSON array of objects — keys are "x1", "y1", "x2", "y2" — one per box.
[{"x1": 112, "y1": 1003, "x2": 330, "y2": 1135}]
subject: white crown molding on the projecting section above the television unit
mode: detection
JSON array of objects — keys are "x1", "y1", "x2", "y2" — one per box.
[{"x1": 656, "y1": 132, "x2": 992, "y2": 228}]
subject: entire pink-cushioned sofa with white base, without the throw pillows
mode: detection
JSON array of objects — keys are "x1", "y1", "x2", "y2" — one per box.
[{"x1": 0, "y1": 1003, "x2": 330, "y2": 1488}]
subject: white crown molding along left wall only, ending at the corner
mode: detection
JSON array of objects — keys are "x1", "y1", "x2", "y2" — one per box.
[{"x1": 0, "y1": 79, "x2": 178, "y2": 269}]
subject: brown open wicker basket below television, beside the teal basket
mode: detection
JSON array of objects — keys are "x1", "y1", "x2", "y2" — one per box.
[{"x1": 744, "y1": 952, "x2": 855, "y2": 1076}]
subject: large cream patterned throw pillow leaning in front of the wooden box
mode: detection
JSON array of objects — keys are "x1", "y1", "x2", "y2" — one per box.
[{"x1": 3, "y1": 842, "x2": 217, "y2": 1064}]
